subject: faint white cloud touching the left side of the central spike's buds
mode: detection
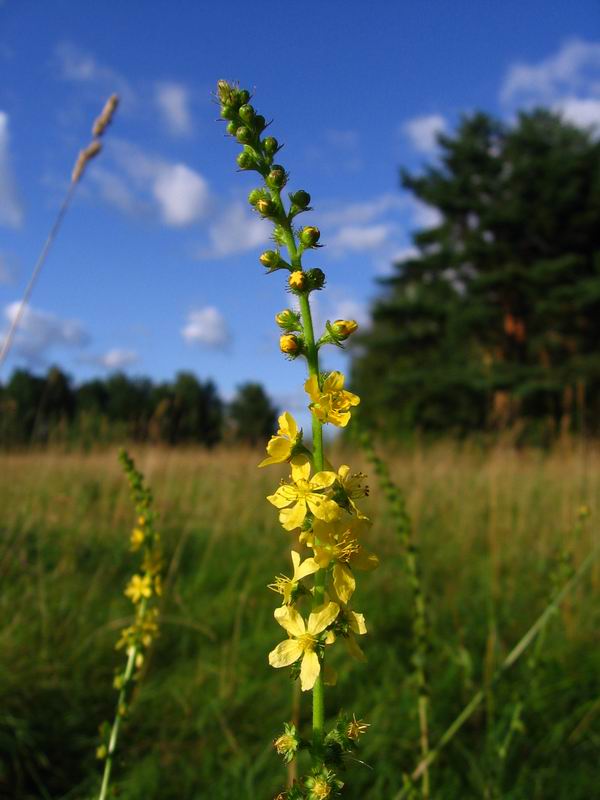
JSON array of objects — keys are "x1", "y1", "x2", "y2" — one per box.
[{"x1": 198, "y1": 203, "x2": 271, "y2": 258}]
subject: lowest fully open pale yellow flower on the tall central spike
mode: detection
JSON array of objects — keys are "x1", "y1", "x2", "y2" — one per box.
[{"x1": 269, "y1": 603, "x2": 340, "y2": 692}]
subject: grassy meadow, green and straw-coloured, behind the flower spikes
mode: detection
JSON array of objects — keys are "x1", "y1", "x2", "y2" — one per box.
[{"x1": 0, "y1": 445, "x2": 600, "y2": 800}]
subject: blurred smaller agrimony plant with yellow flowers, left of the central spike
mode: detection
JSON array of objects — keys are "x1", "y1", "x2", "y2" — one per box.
[{"x1": 97, "y1": 450, "x2": 163, "y2": 800}]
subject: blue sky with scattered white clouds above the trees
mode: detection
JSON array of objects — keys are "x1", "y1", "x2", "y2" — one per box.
[{"x1": 0, "y1": 0, "x2": 600, "y2": 418}]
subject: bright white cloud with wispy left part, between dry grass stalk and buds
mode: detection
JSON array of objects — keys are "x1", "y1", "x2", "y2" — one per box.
[{"x1": 90, "y1": 138, "x2": 212, "y2": 227}]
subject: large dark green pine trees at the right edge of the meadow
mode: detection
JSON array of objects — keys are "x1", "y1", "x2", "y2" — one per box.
[{"x1": 353, "y1": 110, "x2": 600, "y2": 438}]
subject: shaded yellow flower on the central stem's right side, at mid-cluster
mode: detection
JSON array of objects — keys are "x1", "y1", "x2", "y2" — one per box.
[{"x1": 312, "y1": 515, "x2": 379, "y2": 603}]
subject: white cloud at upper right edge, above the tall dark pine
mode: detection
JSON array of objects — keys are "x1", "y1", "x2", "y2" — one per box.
[{"x1": 500, "y1": 39, "x2": 600, "y2": 103}]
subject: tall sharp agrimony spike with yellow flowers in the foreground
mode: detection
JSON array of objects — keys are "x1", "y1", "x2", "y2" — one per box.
[{"x1": 217, "y1": 80, "x2": 378, "y2": 800}]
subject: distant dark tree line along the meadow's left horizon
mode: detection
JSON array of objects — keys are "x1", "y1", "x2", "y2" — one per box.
[{"x1": 0, "y1": 366, "x2": 277, "y2": 447}]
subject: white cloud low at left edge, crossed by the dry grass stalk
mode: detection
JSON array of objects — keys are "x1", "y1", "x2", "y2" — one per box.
[{"x1": 4, "y1": 301, "x2": 89, "y2": 364}]
